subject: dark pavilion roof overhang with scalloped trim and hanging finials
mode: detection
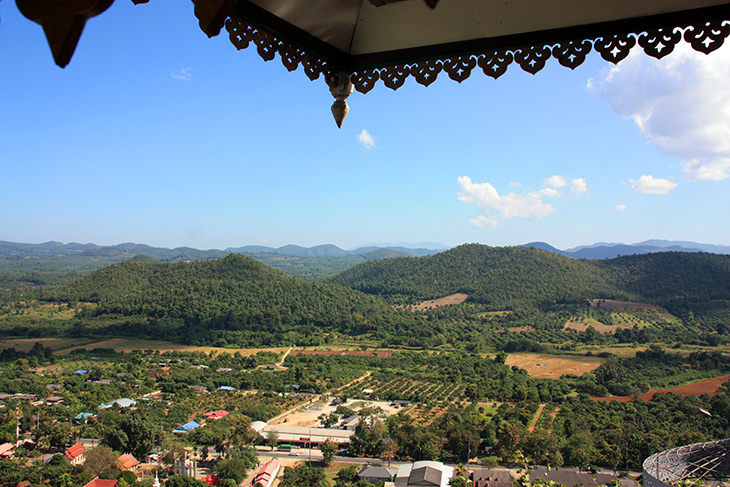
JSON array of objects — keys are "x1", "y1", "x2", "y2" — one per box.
[{"x1": 9, "y1": 0, "x2": 730, "y2": 126}]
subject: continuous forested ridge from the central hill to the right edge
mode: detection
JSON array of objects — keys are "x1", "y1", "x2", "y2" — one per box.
[{"x1": 329, "y1": 244, "x2": 730, "y2": 309}]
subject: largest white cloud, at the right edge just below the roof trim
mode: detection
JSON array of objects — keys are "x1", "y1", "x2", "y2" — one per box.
[{"x1": 588, "y1": 43, "x2": 730, "y2": 181}]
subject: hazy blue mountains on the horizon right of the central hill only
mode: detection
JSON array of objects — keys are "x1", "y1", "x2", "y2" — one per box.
[{"x1": 523, "y1": 240, "x2": 730, "y2": 260}]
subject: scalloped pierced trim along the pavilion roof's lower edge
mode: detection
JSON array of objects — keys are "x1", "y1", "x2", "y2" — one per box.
[{"x1": 226, "y1": 16, "x2": 730, "y2": 93}]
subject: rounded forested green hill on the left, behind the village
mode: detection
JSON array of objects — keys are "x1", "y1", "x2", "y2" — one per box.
[{"x1": 46, "y1": 254, "x2": 415, "y2": 343}]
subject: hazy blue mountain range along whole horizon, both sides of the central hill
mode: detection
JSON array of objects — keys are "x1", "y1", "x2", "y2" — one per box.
[{"x1": 0, "y1": 240, "x2": 730, "y2": 280}]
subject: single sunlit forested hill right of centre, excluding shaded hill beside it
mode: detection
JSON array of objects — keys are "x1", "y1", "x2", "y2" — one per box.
[{"x1": 330, "y1": 244, "x2": 628, "y2": 309}]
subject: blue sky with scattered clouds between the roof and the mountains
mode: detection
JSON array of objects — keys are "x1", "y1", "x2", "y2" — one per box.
[{"x1": 0, "y1": 0, "x2": 730, "y2": 249}]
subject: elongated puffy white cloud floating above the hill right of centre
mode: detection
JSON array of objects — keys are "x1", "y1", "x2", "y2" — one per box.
[{"x1": 457, "y1": 176, "x2": 557, "y2": 226}]
